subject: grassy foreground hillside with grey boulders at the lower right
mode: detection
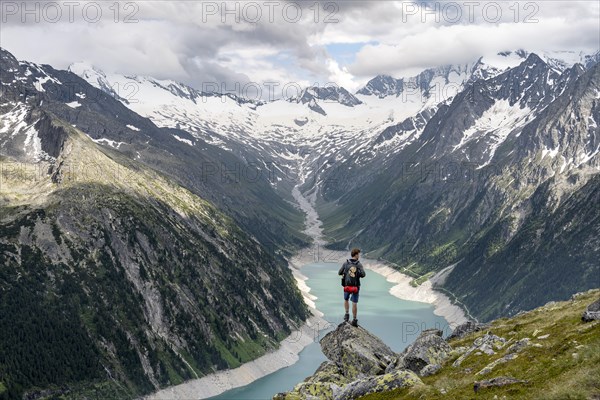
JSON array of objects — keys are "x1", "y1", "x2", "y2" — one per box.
[{"x1": 276, "y1": 289, "x2": 600, "y2": 400}]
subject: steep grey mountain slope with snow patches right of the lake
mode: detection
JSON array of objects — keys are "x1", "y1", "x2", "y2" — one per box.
[{"x1": 321, "y1": 54, "x2": 600, "y2": 319}]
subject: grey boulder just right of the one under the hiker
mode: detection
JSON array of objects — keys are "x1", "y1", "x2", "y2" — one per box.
[{"x1": 397, "y1": 329, "x2": 452, "y2": 376}]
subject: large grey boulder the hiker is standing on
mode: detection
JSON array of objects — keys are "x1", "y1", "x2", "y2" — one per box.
[{"x1": 320, "y1": 323, "x2": 396, "y2": 379}]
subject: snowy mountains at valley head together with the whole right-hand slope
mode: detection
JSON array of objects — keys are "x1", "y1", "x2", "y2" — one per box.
[{"x1": 65, "y1": 45, "x2": 600, "y2": 319}]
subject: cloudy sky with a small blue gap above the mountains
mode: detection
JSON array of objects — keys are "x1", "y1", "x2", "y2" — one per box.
[{"x1": 0, "y1": 0, "x2": 600, "y2": 96}]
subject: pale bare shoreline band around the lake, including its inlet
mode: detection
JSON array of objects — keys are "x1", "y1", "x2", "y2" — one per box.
[{"x1": 142, "y1": 182, "x2": 467, "y2": 400}]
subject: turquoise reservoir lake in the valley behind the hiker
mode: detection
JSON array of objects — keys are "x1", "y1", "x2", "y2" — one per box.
[{"x1": 211, "y1": 262, "x2": 450, "y2": 400}]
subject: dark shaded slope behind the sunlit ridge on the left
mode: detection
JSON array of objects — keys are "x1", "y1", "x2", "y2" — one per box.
[{"x1": 0, "y1": 49, "x2": 307, "y2": 254}]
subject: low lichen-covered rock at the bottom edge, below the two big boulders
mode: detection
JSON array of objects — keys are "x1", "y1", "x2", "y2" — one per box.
[{"x1": 334, "y1": 370, "x2": 423, "y2": 400}]
